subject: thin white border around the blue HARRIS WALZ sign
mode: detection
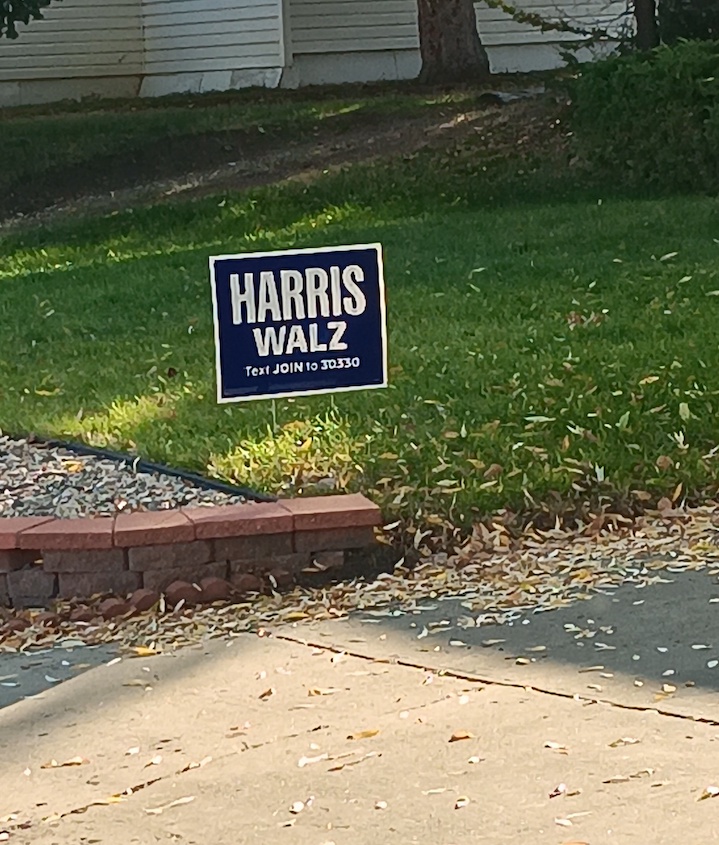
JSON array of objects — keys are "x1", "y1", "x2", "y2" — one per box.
[{"x1": 209, "y1": 243, "x2": 389, "y2": 405}]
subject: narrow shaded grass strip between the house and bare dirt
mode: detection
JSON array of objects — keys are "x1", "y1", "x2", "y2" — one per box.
[{"x1": 0, "y1": 91, "x2": 480, "y2": 199}]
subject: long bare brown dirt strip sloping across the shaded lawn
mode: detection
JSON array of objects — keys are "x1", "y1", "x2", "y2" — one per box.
[{"x1": 0, "y1": 94, "x2": 560, "y2": 229}]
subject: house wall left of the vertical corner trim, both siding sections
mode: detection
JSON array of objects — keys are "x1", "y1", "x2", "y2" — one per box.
[{"x1": 0, "y1": 0, "x2": 285, "y2": 106}]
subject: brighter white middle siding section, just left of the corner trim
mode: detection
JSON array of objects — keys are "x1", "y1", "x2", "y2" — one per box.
[{"x1": 141, "y1": 0, "x2": 285, "y2": 96}]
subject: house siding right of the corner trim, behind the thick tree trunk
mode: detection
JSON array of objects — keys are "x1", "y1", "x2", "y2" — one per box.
[{"x1": 285, "y1": 0, "x2": 627, "y2": 85}]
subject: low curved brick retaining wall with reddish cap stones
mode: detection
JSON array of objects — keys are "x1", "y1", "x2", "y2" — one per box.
[{"x1": 0, "y1": 494, "x2": 381, "y2": 609}]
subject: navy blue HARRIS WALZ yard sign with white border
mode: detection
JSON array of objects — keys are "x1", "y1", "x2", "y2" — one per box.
[{"x1": 210, "y1": 244, "x2": 387, "y2": 402}]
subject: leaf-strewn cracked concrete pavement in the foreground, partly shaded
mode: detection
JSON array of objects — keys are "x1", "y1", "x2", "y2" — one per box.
[{"x1": 0, "y1": 574, "x2": 719, "y2": 845}]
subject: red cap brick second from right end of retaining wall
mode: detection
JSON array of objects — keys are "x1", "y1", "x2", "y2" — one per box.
[{"x1": 182, "y1": 502, "x2": 293, "y2": 539}]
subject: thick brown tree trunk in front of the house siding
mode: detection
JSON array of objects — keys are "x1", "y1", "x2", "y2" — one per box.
[{"x1": 417, "y1": 0, "x2": 489, "y2": 83}]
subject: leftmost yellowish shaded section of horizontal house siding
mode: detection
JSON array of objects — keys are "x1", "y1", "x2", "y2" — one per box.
[{"x1": 0, "y1": 0, "x2": 142, "y2": 105}]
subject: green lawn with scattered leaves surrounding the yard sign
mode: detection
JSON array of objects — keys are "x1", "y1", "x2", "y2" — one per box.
[{"x1": 0, "y1": 94, "x2": 719, "y2": 524}]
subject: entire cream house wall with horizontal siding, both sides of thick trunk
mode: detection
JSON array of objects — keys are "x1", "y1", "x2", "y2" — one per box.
[{"x1": 0, "y1": 0, "x2": 628, "y2": 106}]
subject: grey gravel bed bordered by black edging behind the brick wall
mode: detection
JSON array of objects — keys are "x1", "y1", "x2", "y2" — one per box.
[{"x1": 0, "y1": 435, "x2": 247, "y2": 519}]
